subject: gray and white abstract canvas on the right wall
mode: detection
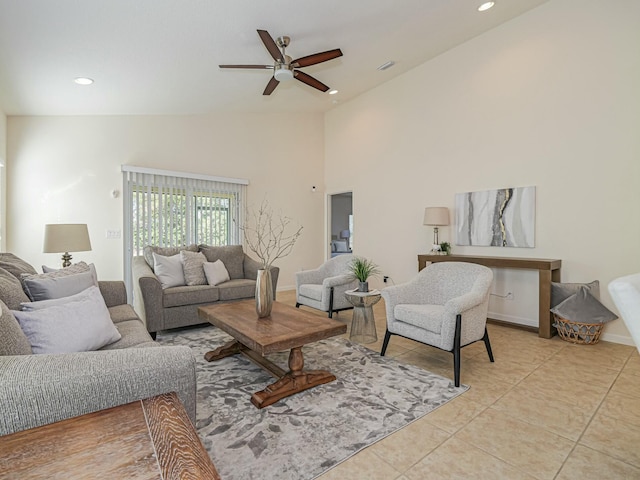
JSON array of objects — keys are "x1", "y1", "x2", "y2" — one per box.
[{"x1": 456, "y1": 187, "x2": 536, "y2": 248}]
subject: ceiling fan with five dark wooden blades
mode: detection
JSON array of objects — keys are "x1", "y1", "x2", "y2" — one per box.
[{"x1": 218, "y1": 30, "x2": 342, "y2": 95}]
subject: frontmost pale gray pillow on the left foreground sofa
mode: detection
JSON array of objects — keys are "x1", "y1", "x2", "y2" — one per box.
[{"x1": 12, "y1": 287, "x2": 121, "y2": 353}]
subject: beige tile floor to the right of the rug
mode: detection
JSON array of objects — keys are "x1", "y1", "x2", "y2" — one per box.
[{"x1": 278, "y1": 291, "x2": 640, "y2": 480}]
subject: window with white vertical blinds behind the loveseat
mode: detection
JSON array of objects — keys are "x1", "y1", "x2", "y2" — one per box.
[{"x1": 122, "y1": 165, "x2": 248, "y2": 298}]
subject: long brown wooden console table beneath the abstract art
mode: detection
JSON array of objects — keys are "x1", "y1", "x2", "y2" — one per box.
[{"x1": 418, "y1": 255, "x2": 562, "y2": 338}]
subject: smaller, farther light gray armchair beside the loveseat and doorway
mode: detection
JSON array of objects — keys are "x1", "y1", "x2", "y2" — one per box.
[{"x1": 296, "y1": 254, "x2": 358, "y2": 318}]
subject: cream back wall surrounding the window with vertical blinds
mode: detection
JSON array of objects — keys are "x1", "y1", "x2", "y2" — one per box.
[{"x1": 7, "y1": 114, "x2": 324, "y2": 288}]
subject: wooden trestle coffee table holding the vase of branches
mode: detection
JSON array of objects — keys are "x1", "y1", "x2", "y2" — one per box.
[{"x1": 198, "y1": 300, "x2": 347, "y2": 408}]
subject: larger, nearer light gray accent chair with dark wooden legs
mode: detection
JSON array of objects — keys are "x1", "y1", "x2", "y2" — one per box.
[{"x1": 380, "y1": 262, "x2": 493, "y2": 387}]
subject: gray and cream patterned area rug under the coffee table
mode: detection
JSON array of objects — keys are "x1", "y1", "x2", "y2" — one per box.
[{"x1": 157, "y1": 326, "x2": 468, "y2": 480}]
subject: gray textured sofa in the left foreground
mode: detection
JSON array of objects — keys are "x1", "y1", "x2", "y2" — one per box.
[{"x1": 0, "y1": 253, "x2": 196, "y2": 435}]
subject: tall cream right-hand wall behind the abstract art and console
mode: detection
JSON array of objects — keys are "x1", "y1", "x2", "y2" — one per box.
[{"x1": 325, "y1": 0, "x2": 640, "y2": 344}]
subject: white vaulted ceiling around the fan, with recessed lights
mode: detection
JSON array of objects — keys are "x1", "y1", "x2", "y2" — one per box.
[{"x1": 0, "y1": 0, "x2": 547, "y2": 115}]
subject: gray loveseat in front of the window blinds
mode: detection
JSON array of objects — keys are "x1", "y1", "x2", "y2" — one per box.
[{"x1": 132, "y1": 245, "x2": 280, "y2": 338}]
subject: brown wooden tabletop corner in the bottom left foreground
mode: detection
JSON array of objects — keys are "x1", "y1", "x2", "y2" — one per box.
[{"x1": 0, "y1": 393, "x2": 220, "y2": 480}]
